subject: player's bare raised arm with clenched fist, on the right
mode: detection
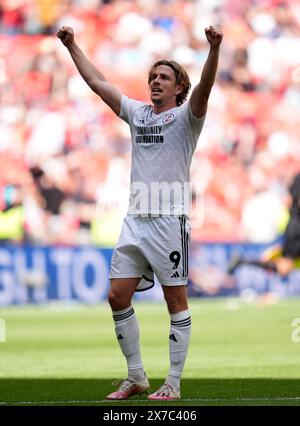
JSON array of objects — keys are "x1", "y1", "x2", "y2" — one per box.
[{"x1": 190, "y1": 26, "x2": 223, "y2": 117}]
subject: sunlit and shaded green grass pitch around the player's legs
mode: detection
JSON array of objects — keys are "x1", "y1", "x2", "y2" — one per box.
[{"x1": 0, "y1": 299, "x2": 300, "y2": 406}]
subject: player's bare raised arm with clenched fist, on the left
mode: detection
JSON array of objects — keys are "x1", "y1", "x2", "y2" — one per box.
[{"x1": 56, "y1": 27, "x2": 122, "y2": 115}]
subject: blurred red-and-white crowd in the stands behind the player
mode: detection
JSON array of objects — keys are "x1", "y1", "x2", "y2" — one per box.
[{"x1": 0, "y1": 0, "x2": 300, "y2": 246}]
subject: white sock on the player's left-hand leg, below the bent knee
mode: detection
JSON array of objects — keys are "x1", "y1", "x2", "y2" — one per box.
[{"x1": 112, "y1": 306, "x2": 145, "y2": 379}]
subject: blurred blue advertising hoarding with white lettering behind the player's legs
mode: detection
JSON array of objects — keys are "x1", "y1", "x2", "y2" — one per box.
[{"x1": 0, "y1": 243, "x2": 300, "y2": 306}]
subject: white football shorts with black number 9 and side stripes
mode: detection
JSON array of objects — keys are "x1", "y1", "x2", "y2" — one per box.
[{"x1": 110, "y1": 214, "x2": 190, "y2": 291}]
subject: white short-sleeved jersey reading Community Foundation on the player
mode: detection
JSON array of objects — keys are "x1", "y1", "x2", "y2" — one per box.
[{"x1": 120, "y1": 95, "x2": 205, "y2": 217}]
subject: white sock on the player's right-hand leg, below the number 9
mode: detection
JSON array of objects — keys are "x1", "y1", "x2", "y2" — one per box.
[{"x1": 166, "y1": 309, "x2": 191, "y2": 390}]
